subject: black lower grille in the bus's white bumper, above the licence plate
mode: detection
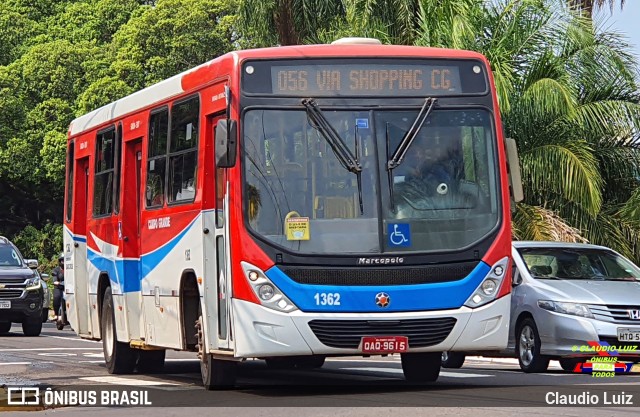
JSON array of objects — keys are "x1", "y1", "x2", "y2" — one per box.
[{"x1": 309, "y1": 317, "x2": 456, "y2": 349}]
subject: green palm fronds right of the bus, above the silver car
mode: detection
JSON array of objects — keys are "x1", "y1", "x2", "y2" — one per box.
[{"x1": 448, "y1": 0, "x2": 640, "y2": 260}]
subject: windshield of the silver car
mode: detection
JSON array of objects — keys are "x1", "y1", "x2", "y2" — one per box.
[{"x1": 518, "y1": 248, "x2": 640, "y2": 281}]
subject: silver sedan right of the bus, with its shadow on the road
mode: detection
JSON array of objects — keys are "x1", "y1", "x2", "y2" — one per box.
[{"x1": 443, "y1": 242, "x2": 640, "y2": 372}]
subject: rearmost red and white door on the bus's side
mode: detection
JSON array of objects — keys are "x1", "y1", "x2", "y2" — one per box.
[{"x1": 69, "y1": 157, "x2": 92, "y2": 336}]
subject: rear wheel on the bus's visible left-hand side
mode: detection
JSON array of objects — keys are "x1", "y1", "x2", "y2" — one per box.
[{"x1": 100, "y1": 287, "x2": 137, "y2": 374}]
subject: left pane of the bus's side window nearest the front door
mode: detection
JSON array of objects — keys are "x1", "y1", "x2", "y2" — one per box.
[{"x1": 145, "y1": 108, "x2": 169, "y2": 207}]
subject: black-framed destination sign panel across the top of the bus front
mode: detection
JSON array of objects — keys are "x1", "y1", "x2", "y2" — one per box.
[{"x1": 242, "y1": 58, "x2": 488, "y2": 97}]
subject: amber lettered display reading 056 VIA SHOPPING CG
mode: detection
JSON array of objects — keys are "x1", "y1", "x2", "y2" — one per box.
[{"x1": 271, "y1": 65, "x2": 461, "y2": 96}]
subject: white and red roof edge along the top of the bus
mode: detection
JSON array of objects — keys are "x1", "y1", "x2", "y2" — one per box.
[{"x1": 69, "y1": 44, "x2": 486, "y2": 137}]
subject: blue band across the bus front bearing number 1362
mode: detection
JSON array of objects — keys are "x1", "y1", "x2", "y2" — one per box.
[{"x1": 266, "y1": 262, "x2": 490, "y2": 313}]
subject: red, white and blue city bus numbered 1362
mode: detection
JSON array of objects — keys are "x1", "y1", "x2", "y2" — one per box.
[{"x1": 64, "y1": 39, "x2": 519, "y2": 389}]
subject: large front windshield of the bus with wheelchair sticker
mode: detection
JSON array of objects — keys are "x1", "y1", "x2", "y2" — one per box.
[{"x1": 242, "y1": 109, "x2": 500, "y2": 254}]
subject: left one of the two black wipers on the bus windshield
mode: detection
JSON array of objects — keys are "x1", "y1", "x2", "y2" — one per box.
[{"x1": 302, "y1": 98, "x2": 364, "y2": 215}]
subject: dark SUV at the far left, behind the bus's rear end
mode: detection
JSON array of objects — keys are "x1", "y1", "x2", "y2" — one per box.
[{"x1": 0, "y1": 236, "x2": 44, "y2": 336}]
